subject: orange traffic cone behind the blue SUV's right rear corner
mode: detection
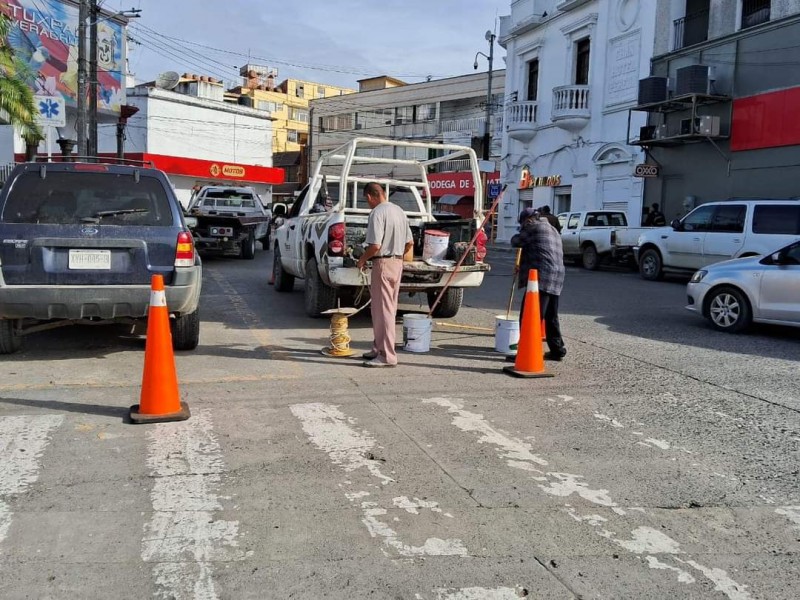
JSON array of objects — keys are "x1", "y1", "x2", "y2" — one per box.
[{"x1": 131, "y1": 275, "x2": 194, "y2": 423}]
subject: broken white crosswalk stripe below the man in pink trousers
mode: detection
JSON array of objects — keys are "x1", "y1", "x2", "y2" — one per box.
[{"x1": 290, "y1": 402, "x2": 468, "y2": 557}]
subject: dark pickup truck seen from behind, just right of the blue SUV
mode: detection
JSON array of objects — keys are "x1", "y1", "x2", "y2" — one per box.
[{"x1": 187, "y1": 185, "x2": 271, "y2": 259}]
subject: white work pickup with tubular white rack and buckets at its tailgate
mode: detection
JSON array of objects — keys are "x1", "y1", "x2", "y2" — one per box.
[{"x1": 273, "y1": 138, "x2": 490, "y2": 317}]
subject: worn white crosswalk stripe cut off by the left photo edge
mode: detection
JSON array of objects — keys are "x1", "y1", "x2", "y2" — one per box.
[{"x1": 0, "y1": 415, "x2": 64, "y2": 543}]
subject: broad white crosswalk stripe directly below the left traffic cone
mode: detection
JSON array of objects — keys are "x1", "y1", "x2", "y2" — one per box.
[{"x1": 142, "y1": 410, "x2": 245, "y2": 600}]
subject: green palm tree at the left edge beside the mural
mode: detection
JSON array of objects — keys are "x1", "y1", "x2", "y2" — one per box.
[{"x1": 0, "y1": 12, "x2": 42, "y2": 142}]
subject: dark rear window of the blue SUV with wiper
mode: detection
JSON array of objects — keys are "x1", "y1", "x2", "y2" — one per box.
[{"x1": 2, "y1": 171, "x2": 173, "y2": 227}]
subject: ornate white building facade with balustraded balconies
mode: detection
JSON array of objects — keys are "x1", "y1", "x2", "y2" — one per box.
[{"x1": 497, "y1": 0, "x2": 656, "y2": 240}]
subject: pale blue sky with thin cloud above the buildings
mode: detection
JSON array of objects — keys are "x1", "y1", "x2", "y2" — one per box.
[{"x1": 114, "y1": 0, "x2": 511, "y2": 88}]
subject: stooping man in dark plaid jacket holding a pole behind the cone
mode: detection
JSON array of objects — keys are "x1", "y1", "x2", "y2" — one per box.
[{"x1": 511, "y1": 208, "x2": 567, "y2": 360}]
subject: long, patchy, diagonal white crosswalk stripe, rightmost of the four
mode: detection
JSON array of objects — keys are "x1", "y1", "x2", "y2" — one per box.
[{"x1": 422, "y1": 398, "x2": 751, "y2": 600}]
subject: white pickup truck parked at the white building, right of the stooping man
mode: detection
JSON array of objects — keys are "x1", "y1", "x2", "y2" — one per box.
[{"x1": 558, "y1": 210, "x2": 638, "y2": 271}]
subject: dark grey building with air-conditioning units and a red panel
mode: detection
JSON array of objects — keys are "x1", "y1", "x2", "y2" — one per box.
[{"x1": 630, "y1": 0, "x2": 800, "y2": 220}]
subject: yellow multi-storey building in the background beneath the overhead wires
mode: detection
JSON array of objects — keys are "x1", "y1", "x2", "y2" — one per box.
[{"x1": 231, "y1": 65, "x2": 355, "y2": 153}]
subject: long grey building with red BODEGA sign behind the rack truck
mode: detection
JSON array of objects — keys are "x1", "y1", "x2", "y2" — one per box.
[{"x1": 310, "y1": 71, "x2": 505, "y2": 216}]
